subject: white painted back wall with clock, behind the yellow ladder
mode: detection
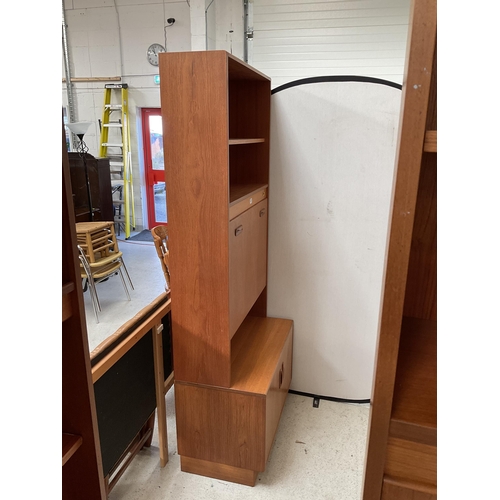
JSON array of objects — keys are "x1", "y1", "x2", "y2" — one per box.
[{"x1": 62, "y1": 0, "x2": 191, "y2": 229}]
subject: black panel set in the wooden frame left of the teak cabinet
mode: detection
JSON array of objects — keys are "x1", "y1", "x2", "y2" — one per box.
[{"x1": 94, "y1": 330, "x2": 156, "y2": 476}]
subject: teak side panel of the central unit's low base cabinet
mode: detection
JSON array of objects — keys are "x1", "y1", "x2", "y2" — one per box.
[{"x1": 175, "y1": 382, "x2": 266, "y2": 471}]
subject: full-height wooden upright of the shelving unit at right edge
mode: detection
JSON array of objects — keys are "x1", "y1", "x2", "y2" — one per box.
[{"x1": 363, "y1": 0, "x2": 437, "y2": 500}]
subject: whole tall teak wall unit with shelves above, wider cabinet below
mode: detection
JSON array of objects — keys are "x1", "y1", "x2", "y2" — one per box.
[{"x1": 160, "y1": 51, "x2": 293, "y2": 486}]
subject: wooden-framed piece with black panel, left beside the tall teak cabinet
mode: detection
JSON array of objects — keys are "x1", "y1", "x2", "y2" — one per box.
[{"x1": 90, "y1": 293, "x2": 174, "y2": 493}]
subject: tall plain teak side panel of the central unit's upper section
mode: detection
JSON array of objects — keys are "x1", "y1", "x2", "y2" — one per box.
[{"x1": 160, "y1": 51, "x2": 230, "y2": 387}]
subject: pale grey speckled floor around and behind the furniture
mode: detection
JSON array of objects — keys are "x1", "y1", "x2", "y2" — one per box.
[{"x1": 84, "y1": 236, "x2": 369, "y2": 500}]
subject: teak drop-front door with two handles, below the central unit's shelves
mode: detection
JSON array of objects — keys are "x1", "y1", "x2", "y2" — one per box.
[{"x1": 229, "y1": 199, "x2": 267, "y2": 337}]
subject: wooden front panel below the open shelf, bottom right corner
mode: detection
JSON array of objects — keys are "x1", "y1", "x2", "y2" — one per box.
[{"x1": 385, "y1": 438, "x2": 437, "y2": 486}]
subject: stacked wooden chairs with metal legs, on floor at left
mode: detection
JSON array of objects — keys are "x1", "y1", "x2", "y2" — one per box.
[{"x1": 76, "y1": 222, "x2": 134, "y2": 323}]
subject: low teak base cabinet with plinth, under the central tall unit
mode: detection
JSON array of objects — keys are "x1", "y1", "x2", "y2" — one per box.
[{"x1": 175, "y1": 316, "x2": 293, "y2": 486}]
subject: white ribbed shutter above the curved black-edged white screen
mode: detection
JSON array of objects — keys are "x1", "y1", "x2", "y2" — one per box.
[{"x1": 249, "y1": 0, "x2": 410, "y2": 88}]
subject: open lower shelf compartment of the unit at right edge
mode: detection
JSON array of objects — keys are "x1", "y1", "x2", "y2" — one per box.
[{"x1": 390, "y1": 317, "x2": 437, "y2": 445}]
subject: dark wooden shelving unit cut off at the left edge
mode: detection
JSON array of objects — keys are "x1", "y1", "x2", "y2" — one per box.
[{"x1": 61, "y1": 120, "x2": 106, "y2": 500}]
